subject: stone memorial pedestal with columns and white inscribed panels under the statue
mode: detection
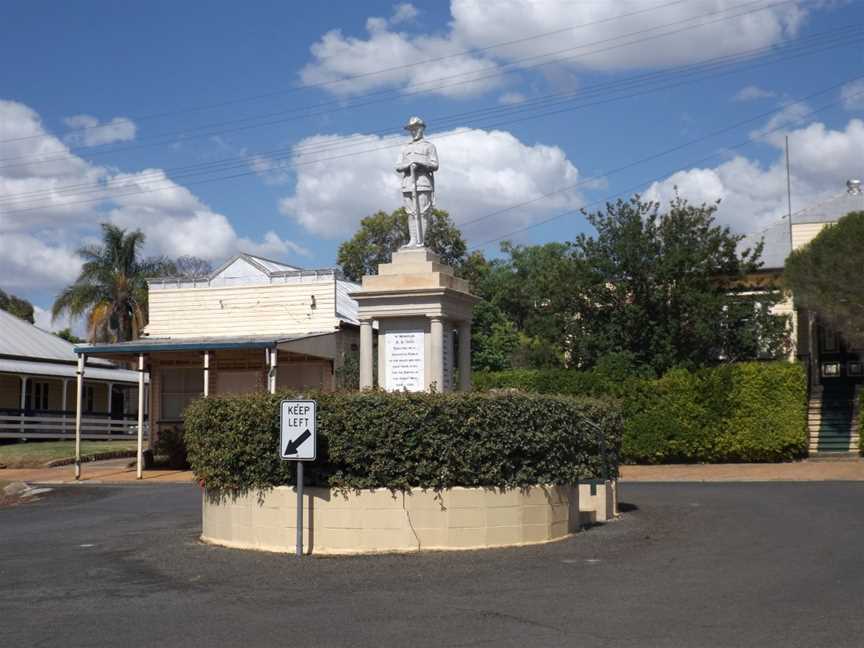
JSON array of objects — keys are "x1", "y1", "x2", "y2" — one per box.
[{"x1": 351, "y1": 248, "x2": 478, "y2": 391}]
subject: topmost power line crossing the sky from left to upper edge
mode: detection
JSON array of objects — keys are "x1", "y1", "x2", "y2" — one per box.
[{"x1": 0, "y1": 0, "x2": 764, "y2": 143}]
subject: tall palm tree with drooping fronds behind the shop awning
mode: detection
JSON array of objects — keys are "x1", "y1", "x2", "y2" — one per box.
[{"x1": 51, "y1": 223, "x2": 170, "y2": 342}]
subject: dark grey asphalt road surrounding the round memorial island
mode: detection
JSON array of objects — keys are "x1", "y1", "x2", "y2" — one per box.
[{"x1": 0, "y1": 482, "x2": 864, "y2": 648}]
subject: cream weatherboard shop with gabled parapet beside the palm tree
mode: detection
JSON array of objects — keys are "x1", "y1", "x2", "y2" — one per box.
[{"x1": 75, "y1": 254, "x2": 359, "y2": 444}]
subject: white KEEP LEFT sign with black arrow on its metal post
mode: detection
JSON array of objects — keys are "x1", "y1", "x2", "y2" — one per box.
[{"x1": 279, "y1": 400, "x2": 318, "y2": 556}]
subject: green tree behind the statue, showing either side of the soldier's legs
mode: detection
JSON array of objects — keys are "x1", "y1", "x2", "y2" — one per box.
[{"x1": 336, "y1": 208, "x2": 466, "y2": 282}]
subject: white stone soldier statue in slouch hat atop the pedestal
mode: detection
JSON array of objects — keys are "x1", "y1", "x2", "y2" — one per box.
[{"x1": 396, "y1": 117, "x2": 438, "y2": 247}]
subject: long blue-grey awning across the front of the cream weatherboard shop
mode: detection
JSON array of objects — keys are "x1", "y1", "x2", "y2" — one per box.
[{"x1": 75, "y1": 331, "x2": 334, "y2": 355}]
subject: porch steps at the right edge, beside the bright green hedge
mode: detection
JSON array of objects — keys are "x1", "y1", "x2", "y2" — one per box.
[{"x1": 807, "y1": 384, "x2": 861, "y2": 457}]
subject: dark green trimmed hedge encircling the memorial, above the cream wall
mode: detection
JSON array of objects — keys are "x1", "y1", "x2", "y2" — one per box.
[{"x1": 185, "y1": 392, "x2": 623, "y2": 494}]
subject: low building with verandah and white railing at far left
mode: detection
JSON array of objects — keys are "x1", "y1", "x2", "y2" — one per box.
[{"x1": 0, "y1": 310, "x2": 138, "y2": 439}]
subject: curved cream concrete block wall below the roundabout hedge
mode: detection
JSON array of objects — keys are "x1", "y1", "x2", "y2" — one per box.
[{"x1": 201, "y1": 485, "x2": 614, "y2": 554}]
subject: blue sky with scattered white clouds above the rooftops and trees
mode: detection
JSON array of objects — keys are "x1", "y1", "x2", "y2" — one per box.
[{"x1": 0, "y1": 0, "x2": 864, "y2": 329}]
